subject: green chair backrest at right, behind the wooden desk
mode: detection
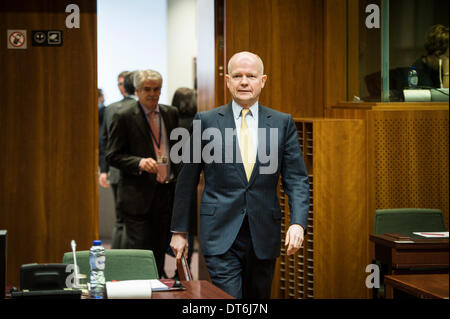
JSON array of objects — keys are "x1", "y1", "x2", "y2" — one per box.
[{"x1": 374, "y1": 208, "x2": 446, "y2": 235}]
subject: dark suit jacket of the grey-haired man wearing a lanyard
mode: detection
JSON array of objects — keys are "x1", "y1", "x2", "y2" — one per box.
[{"x1": 106, "y1": 101, "x2": 178, "y2": 215}]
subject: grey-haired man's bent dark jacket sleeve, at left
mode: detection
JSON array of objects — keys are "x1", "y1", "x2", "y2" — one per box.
[{"x1": 106, "y1": 112, "x2": 142, "y2": 175}]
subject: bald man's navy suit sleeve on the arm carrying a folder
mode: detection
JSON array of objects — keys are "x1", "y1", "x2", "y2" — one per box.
[{"x1": 170, "y1": 114, "x2": 203, "y2": 232}]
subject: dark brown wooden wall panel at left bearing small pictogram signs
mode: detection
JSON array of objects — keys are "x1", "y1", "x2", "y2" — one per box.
[{"x1": 0, "y1": 0, "x2": 98, "y2": 285}]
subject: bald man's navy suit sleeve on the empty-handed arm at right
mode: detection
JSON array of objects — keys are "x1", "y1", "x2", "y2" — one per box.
[{"x1": 281, "y1": 115, "x2": 309, "y2": 232}]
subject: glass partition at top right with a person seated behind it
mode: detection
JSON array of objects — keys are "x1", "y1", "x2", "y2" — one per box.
[{"x1": 354, "y1": 0, "x2": 449, "y2": 102}]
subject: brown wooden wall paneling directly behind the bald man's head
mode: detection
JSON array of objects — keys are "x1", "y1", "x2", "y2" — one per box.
[{"x1": 225, "y1": 0, "x2": 324, "y2": 117}]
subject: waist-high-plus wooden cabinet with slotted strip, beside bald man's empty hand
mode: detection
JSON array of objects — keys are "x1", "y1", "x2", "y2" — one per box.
[{"x1": 272, "y1": 118, "x2": 370, "y2": 299}]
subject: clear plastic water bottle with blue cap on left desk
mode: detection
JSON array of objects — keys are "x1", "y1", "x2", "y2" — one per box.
[{"x1": 89, "y1": 240, "x2": 105, "y2": 299}]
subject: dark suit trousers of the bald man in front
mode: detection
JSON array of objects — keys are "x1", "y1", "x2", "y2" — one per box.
[{"x1": 204, "y1": 217, "x2": 276, "y2": 299}]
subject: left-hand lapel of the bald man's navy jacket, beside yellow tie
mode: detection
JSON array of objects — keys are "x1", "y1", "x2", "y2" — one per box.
[{"x1": 217, "y1": 102, "x2": 247, "y2": 184}]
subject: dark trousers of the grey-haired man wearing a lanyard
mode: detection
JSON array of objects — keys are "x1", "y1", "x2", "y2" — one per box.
[{"x1": 122, "y1": 183, "x2": 175, "y2": 276}]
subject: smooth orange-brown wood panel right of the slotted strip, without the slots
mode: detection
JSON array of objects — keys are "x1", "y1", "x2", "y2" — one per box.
[{"x1": 313, "y1": 120, "x2": 370, "y2": 298}]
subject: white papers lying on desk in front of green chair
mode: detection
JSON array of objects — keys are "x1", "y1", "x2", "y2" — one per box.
[{"x1": 106, "y1": 279, "x2": 169, "y2": 299}]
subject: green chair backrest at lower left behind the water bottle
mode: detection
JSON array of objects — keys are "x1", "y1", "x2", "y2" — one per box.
[{"x1": 63, "y1": 249, "x2": 159, "y2": 281}]
